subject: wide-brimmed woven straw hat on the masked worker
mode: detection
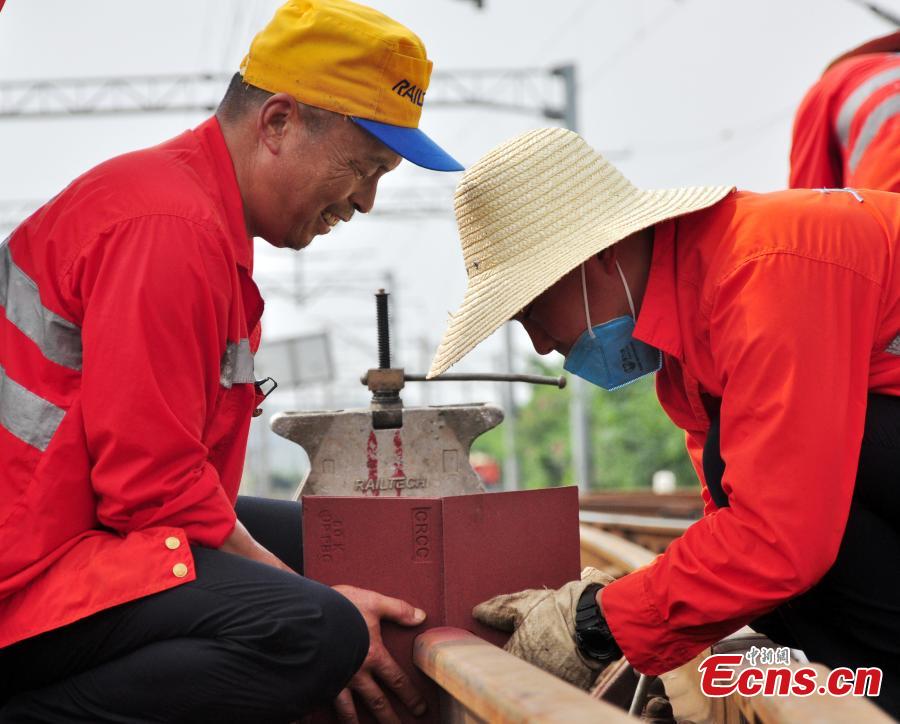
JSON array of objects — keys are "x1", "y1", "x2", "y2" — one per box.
[{"x1": 428, "y1": 128, "x2": 732, "y2": 377}]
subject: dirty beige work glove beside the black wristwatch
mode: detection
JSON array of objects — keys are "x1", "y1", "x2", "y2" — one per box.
[{"x1": 472, "y1": 567, "x2": 613, "y2": 689}]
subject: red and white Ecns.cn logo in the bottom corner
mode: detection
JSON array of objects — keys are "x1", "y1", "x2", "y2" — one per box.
[{"x1": 698, "y1": 646, "x2": 882, "y2": 697}]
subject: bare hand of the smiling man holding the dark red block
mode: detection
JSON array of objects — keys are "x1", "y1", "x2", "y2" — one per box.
[{"x1": 332, "y1": 585, "x2": 426, "y2": 724}]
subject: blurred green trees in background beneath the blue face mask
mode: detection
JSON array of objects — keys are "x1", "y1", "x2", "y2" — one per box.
[{"x1": 472, "y1": 361, "x2": 697, "y2": 489}]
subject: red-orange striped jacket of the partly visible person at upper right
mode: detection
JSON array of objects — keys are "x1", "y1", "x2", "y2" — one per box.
[{"x1": 790, "y1": 53, "x2": 900, "y2": 191}]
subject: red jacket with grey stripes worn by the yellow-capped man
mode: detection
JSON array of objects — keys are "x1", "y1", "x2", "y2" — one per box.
[{"x1": 0, "y1": 118, "x2": 263, "y2": 647}]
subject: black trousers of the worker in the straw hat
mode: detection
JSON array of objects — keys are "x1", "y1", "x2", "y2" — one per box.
[{"x1": 703, "y1": 395, "x2": 900, "y2": 718}]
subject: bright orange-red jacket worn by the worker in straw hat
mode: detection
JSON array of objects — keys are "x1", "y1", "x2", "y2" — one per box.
[{"x1": 603, "y1": 190, "x2": 900, "y2": 674}]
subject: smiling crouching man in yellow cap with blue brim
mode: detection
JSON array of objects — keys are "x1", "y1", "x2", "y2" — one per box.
[{"x1": 0, "y1": 0, "x2": 460, "y2": 722}]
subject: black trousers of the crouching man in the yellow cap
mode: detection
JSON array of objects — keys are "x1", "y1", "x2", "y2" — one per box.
[{"x1": 0, "y1": 498, "x2": 369, "y2": 724}]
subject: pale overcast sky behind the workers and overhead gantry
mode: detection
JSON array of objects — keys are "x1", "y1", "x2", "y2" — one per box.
[{"x1": 0, "y1": 0, "x2": 900, "y2": 486}]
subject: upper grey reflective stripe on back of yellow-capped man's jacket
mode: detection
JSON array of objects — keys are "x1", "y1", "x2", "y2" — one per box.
[{"x1": 0, "y1": 237, "x2": 81, "y2": 370}]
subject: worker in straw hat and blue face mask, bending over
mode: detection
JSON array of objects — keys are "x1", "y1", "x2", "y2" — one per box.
[{"x1": 429, "y1": 128, "x2": 900, "y2": 715}]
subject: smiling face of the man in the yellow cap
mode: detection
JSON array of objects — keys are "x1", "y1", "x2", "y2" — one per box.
[{"x1": 248, "y1": 99, "x2": 401, "y2": 249}]
